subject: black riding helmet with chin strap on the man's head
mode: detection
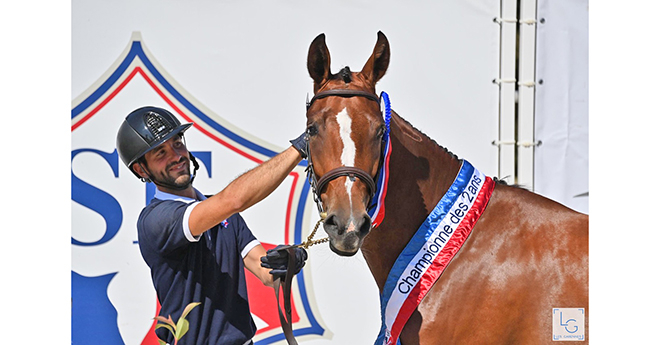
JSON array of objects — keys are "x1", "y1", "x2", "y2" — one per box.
[{"x1": 117, "y1": 107, "x2": 198, "y2": 187}]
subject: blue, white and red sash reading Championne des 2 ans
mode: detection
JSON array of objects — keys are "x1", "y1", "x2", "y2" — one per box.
[{"x1": 376, "y1": 160, "x2": 495, "y2": 345}]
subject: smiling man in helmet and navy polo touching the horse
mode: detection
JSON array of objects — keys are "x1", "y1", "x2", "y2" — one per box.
[{"x1": 117, "y1": 107, "x2": 307, "y2": 345}]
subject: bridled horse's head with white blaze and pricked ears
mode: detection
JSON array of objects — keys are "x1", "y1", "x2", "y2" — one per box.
[{"x1": 307, "y1": 32, "x2": 390, "y2": 256}]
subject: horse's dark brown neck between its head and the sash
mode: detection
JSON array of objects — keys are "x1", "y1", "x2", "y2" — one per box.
[{"x1": 362, "y1": 113, "x2": 461, "y2": 291}]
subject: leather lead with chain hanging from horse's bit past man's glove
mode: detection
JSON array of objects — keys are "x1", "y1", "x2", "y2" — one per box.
[{"x1": 273, "y1": 212, "x2": 330, "y2": 345}]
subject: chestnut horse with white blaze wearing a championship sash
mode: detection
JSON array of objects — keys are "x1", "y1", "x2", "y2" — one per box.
[{"x1": 307, "y1": 32, "x2": 589, "y2": 345}]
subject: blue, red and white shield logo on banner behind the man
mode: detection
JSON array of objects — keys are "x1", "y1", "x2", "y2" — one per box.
[{"x1": 71, "y1": 33, "x2": 326, "y2": 345}]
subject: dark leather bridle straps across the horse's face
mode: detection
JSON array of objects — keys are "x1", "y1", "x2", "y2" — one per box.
[{"x1": 307, "y1": 89, "x2": 380, "y2": 214}]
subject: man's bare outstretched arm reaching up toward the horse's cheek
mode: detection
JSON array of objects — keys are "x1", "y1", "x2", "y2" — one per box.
[{"x1": 188, "y1": 146, "x2": 301, "y2": 236}]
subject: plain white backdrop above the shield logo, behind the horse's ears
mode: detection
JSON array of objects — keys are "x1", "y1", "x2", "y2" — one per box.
[{"x1": 71, "y1": 0, "x2": 499, "y2": 174}]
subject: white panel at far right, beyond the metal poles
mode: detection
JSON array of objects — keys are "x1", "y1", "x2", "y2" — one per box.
[{"x1": 534, "y1": 0, "x2": 589, "y2": 213}]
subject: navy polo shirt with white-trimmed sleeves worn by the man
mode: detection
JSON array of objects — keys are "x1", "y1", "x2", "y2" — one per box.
[{"x1": 137, "y1": 190, "x2": 259, "y2": 345}]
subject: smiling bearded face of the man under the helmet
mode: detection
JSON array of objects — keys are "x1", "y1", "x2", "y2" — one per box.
[{"x1": 138, "y1": 135, "x2": 190, "y2": 188}]
